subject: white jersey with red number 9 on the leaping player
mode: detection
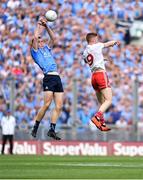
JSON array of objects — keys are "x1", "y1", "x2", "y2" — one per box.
[{"x1": 83, "y1": 42, "x2": 105, "y2": 72}]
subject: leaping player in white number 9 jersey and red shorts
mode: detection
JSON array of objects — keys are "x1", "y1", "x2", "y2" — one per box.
[{"x1": 83, "y1": 33, "x2": 120, "y2": 131}]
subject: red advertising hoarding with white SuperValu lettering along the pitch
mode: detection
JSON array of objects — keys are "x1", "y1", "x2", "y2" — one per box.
[{"x1": 0, "y1": 141, "x2": 143, "y2": 156}]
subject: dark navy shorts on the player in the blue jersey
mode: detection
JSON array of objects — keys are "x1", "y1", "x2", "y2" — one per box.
[{"x1": 43, "y1": 74, "x2": 64, "y2": 92}]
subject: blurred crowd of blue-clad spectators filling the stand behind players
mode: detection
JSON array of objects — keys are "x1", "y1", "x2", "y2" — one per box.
[{"x1": 0, "y1": 0, "x2": 143, "y2": 130}]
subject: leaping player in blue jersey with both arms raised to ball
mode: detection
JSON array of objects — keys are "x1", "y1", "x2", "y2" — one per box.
[{"x1": 31, "y1": 17, "x2": 63, "y2": 140}]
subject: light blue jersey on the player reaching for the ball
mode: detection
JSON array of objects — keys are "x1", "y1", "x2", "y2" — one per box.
[{"x1": 31, "y1": 45, "x2": 57, "y2": 74}]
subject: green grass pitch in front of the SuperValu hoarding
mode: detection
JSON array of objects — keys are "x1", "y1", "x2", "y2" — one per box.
[{"x1": 0, "y1": 155, "x2": 143, "y2": 179}]
